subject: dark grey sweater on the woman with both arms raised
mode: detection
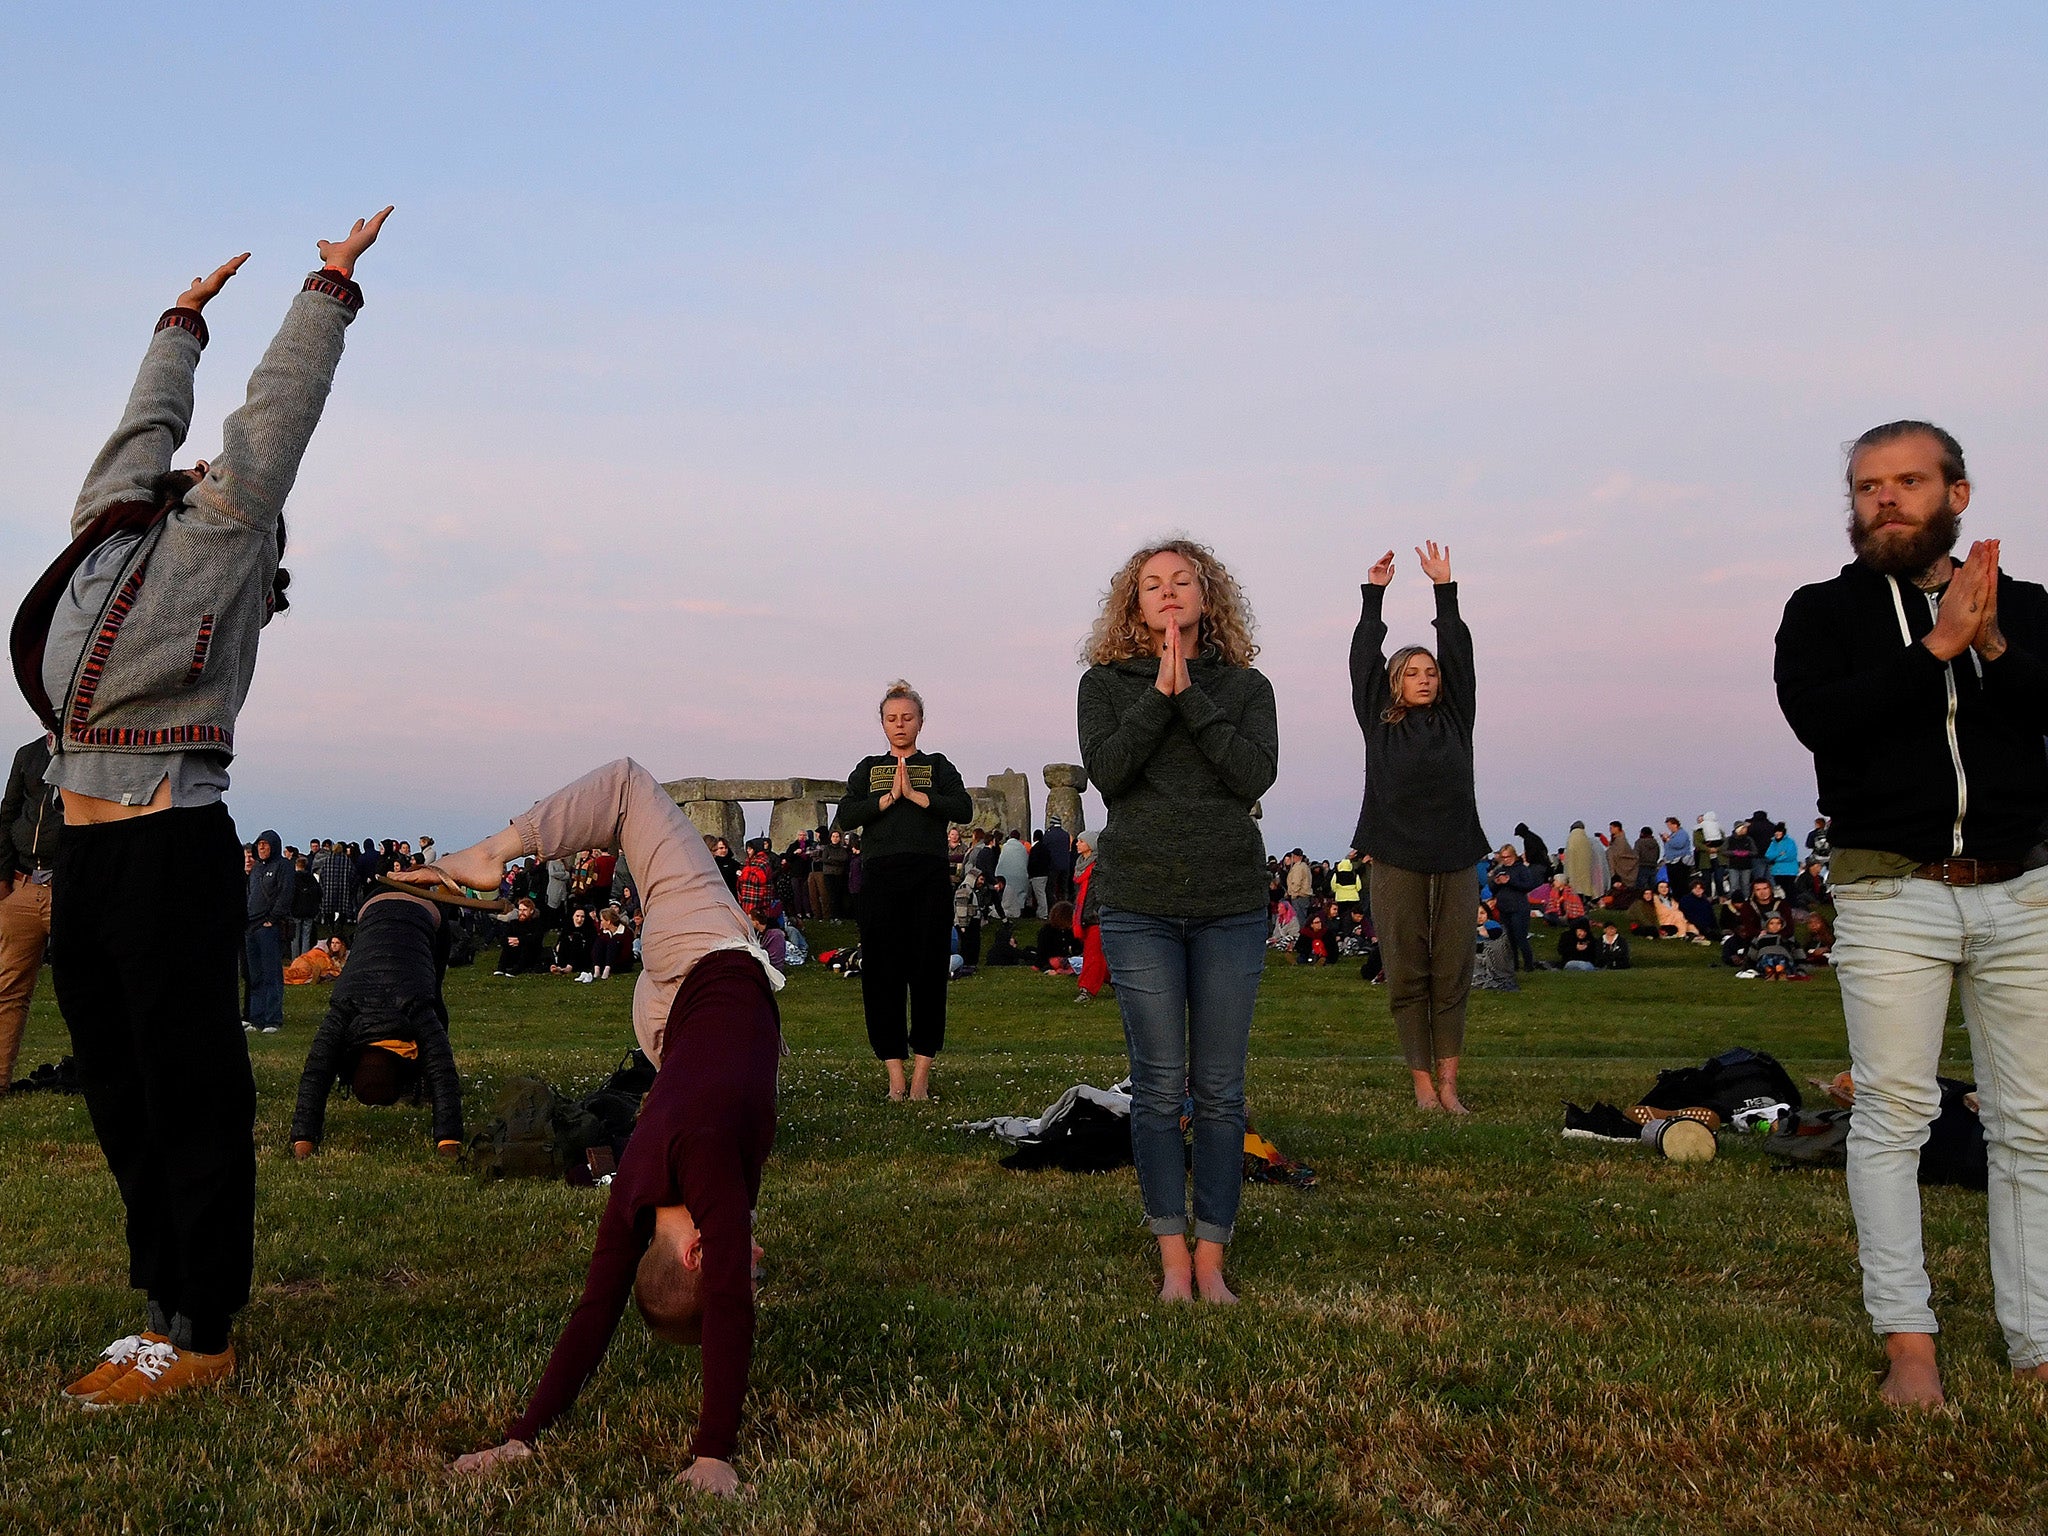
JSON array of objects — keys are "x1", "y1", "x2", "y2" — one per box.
[{"x1": 1352, "y1": 582, "x2": 1487, "y2": 874}]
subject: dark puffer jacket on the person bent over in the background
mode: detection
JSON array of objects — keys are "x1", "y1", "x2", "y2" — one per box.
[{"x1": 291, "y1": 899, "x2": 463, "y2": 1145}]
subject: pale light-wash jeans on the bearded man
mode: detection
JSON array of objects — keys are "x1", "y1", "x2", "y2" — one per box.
[{"x1": 1833, "y1": 868, "x2": 2048, "y2": 1370}]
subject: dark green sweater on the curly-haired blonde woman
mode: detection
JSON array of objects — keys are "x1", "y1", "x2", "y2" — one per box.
[{"x1": 1077, "y1": 653, "x2": 1280, "y2": 918}]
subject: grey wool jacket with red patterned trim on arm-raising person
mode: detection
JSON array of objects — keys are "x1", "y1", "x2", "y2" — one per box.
[{"x1": 45, "y1": 272, "x2": 362, "y2": 758}]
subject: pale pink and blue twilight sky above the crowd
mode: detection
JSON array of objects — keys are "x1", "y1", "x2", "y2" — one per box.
[{"x1": 0, "y1": 2, "x2": 2048, "y2": 852}]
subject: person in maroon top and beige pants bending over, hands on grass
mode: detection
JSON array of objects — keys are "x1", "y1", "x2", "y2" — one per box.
[{"x1": 423, "y1": 758, "x2": 782, "y2": 1493}]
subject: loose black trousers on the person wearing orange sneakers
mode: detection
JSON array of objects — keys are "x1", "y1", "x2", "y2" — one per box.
[{"x1": 49, "y1": 803, "x2": 256, "y2": 1354}]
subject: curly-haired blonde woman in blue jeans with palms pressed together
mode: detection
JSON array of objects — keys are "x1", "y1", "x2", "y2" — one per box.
[{"x1": 1079, "y1": 539, "x2": 1280, "y2": 1303}]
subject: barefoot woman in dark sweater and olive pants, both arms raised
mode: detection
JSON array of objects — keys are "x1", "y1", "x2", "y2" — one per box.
[{"x1": 1352, "y1": 543, "x2": 1489, "y2": 1114}]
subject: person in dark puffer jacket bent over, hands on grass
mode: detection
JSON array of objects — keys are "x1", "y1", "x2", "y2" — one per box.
[{"x1": 291, "y1": 891, "x2": 463, "y2": 1157}]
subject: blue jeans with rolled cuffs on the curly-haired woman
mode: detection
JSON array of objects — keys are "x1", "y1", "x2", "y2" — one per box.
[{"x1": 1102, "y1": 907, "x2": 1266, "y2": 1243}]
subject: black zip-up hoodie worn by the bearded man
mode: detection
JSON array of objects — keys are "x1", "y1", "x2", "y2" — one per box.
[{"x1": 1776, "y1": 561, "x2": 2048, "y2": 862}]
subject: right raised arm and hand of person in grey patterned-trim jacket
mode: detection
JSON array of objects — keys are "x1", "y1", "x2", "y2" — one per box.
[{"x1": 188, "y1": 209, "x2": 391, "y2": 532}]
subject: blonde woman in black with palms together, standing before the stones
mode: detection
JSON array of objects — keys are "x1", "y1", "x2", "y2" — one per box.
[{"x1": 831, "y1": 678, "x2": 975, "y2": 1100}]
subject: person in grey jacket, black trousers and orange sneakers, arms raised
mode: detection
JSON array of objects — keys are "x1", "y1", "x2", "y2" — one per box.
[{"x1": 10, "y1": 209, "x2": 391, "y2": 1407}]
